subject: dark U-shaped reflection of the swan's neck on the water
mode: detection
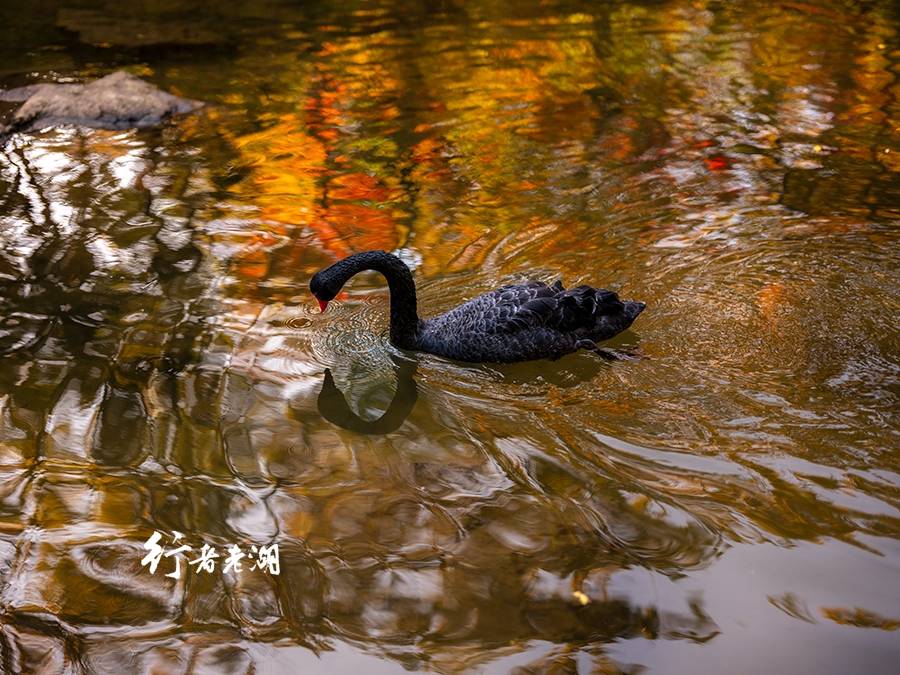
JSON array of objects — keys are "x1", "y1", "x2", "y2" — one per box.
[{"x1": 317, "y1": 355, "x2": 418, "y2": 434}]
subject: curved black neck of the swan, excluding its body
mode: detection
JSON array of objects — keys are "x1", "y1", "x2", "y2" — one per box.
[{"x1": 326, "y1": 251, "x2": 420, "y2": 349}]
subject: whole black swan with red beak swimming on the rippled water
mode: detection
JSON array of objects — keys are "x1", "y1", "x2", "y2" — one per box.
[{"x1": 309, "y1": 251, "x2": 644, "y2": 363}]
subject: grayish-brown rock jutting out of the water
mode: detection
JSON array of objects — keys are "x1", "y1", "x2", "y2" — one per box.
[{"x1": 0, "y1": 71, "x2": 203, "y2": 138}]
